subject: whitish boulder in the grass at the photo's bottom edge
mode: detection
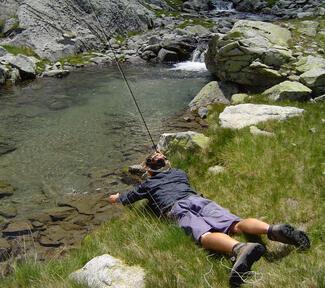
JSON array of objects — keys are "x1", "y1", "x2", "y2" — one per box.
[{"x1": 69, "y1": 254, "x2": 145, "y2": 288}]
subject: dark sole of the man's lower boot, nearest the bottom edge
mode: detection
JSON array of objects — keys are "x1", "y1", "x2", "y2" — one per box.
[{"x1": 229, "y1": 243, "x2": 266, "y2": 288}]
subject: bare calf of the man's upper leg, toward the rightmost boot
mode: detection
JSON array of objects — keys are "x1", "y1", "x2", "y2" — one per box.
[{"x1": 231, "y1": 218, "x2": 270, "y2": 235}]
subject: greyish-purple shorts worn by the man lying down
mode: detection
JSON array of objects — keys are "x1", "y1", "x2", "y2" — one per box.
[{"x1": 169, "y1": 195, "x2": 241, "y2": 243}]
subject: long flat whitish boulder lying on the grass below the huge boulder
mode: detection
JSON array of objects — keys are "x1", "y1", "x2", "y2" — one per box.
[{"x1": 219, "y1": 104, "x2": 304, "y2": 129}]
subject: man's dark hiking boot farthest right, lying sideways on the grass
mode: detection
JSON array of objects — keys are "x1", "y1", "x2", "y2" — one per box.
[{"x1": 267, "y1": 224, "x2": 310, "y2": 249}]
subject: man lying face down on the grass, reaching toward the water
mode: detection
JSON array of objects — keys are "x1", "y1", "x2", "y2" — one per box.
[{"x1": 109, "y1": 153, "x2": 310, "y2": 287}]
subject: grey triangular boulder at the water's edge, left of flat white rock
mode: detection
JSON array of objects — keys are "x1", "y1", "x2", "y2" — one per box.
[{"x1": 188, "y1": 81, "x2": 232, "y2": 111}]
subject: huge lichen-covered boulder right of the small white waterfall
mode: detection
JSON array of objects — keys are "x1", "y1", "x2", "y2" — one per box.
[{"x1": 205, "y1": 20, "x2": 293, "y2": 87}]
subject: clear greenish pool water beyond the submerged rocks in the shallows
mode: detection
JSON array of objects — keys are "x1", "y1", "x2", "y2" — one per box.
[{"x1": 0, "y1": 66, "x2": 209, "y2": 215}]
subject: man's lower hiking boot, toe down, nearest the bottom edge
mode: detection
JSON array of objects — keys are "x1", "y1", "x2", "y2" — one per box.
[{"x1": 229, "y1": 243, "x2": 266, "y2": 288}]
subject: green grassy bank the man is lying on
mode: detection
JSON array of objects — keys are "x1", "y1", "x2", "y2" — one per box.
[{"x1": 0, "y1": 103, "x2": 325, "y2": 288}]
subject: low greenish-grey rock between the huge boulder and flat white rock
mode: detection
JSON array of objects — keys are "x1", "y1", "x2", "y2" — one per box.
[{"x1": 263, "y1": 81, "x2": 312, "y2": 101}]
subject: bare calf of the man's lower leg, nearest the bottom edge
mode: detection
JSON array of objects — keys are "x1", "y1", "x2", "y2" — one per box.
[{"x1": 201, "y1": 232, "x2": 239, "y2": 253}]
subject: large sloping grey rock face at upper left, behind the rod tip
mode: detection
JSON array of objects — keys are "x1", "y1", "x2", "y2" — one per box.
[{"x1": 1, "y1": 0, "x2": 154, "y2": 60}]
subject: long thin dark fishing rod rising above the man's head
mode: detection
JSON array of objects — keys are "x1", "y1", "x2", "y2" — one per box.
[{"x1": 88, "y1": 0, "x2": 158, "y2": 152}]
